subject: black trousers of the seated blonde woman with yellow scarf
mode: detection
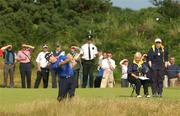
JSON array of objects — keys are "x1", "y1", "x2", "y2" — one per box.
[{"x1": 128, "y1": 76, "x2": 149, "y2": 95}]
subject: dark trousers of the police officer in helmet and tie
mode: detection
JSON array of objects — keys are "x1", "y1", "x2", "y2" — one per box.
[{"x1": 82, "y1": 60, "x2": 94, "y2": 88}]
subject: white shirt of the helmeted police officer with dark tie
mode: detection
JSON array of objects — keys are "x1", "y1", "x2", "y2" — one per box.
[{"x1": 80, "y1": 43, "x2": 98, "y2": 60}]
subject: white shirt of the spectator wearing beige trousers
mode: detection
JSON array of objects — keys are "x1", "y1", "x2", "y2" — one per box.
[{"x1": 102, "y1": 58, "x2": 116, "y2": 69}]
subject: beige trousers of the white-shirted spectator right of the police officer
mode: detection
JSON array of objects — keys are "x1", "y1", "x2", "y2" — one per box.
[{"x1": 100, "y1": 69, "x2": 114, "y2": 88}]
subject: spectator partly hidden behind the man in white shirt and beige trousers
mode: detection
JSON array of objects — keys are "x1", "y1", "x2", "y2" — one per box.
[{"x1": 94, "y1": 52, "x2": 107, "y2": 88}]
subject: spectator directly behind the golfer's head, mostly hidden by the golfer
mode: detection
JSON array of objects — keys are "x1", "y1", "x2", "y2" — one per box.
[{"x1": 51, "y1": 45, "x2": 65, "y2": 88}]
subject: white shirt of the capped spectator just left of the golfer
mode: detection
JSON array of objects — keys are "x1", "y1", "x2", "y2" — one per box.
[{"x1": 36, "y1": 52, "x2": 48, "y2": 68}]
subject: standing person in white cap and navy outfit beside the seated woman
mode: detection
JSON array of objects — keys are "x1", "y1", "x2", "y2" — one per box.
[{"x1": 148, "y1": 38, "x2": 168, "y2": 97}]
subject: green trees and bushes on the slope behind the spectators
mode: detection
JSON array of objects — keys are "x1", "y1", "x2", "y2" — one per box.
[{"x1": 0, "y1": 0, "x2": 180, "y2": 63}]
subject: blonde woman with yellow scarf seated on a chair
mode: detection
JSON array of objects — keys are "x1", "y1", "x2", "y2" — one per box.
[{"x1": 128, "y1": 52, "x2": 150, "y2": 98}]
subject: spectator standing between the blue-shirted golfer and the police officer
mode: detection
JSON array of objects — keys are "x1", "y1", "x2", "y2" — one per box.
[{"x1": 67, "y1": 45, "x2": 81, "y2": 88}]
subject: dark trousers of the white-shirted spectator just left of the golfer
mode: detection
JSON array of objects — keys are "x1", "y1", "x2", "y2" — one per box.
[{"x1": 34, "y1": 68, "x2": 49, "y2": 88}]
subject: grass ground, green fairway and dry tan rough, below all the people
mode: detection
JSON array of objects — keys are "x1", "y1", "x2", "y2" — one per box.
[{"x1": 0, "y1": 88, "x2": 180, "y2": 116}]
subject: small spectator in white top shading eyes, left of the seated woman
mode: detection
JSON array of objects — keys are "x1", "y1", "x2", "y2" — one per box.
[{"x1": 119, "y1": 59, "x2": 129, "y2": 87}]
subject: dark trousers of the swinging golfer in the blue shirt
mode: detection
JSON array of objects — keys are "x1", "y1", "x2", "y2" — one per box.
[{"x1": 58, "y1": 77, "x2": 76, "y2": 99}]
